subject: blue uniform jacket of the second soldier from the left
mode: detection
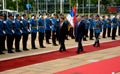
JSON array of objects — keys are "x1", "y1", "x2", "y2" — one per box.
[{"x1": 6, "y1": 19, "x2": 14, "y2": 35}]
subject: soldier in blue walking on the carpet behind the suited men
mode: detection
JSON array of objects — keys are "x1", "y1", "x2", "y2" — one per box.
[{"x1": 93, "y1": 15, "x2": 101, "y2": 47}]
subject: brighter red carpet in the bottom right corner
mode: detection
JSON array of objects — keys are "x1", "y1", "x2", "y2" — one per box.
[{"x1": 55, "y1": 56, "x2": 120, "y2": 74}]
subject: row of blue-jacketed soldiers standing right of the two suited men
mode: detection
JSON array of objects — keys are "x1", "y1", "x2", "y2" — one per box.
[{"x1": 77, "y1": 14, "x2": 120, "y2": 41}]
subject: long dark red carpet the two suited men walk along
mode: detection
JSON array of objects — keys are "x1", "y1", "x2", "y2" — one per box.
[{"x1": 0, "y1": 40, "x2": 120, "y2": 72}]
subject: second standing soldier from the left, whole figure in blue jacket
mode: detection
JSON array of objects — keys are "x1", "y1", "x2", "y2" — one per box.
[{"x1": 6, "y1": 13, "x2": 15, "y2": 53}]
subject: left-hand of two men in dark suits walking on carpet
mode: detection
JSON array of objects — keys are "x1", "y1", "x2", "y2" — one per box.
[{"x1": 59, "y1": 17, "x2": 67, "y2": 52}]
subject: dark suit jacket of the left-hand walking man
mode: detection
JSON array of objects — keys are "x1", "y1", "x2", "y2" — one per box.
[{"x1": 59, "y1": 22, "x2": 68, "y2": 40}]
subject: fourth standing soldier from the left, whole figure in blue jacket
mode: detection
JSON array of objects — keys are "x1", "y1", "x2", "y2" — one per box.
[{"x1": 22, "y1": 14, "x2": 30, "y2": 51}]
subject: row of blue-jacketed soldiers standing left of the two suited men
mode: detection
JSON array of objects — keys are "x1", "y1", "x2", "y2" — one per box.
[{"x1": 0, "y1": 14, "x2": 67, "y2": 54}]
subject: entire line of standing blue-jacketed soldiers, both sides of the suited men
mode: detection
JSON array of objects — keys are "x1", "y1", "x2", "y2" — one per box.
[{"x1": 0, "y1": 14, "x2": 120, "y2": 54}]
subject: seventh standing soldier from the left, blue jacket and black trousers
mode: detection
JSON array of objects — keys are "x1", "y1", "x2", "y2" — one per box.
[{"x1": 45, "y1": 14, "x2": 52, "y2": 44}]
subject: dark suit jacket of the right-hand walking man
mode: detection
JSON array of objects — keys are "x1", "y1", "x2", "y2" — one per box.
[{"x1": 76, "y1": 21, "x2": 85, "y2": 39}]
